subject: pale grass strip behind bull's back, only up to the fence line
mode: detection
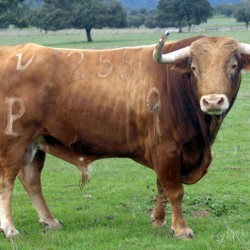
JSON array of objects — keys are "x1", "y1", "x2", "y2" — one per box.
[{"x1": 0, "y1": 29, "x2": 250, "y2": 49}]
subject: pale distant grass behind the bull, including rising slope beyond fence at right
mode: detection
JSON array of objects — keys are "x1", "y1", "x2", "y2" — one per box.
[{"x1": 0, "y1": 15, "x2": 250, "y2": 49}]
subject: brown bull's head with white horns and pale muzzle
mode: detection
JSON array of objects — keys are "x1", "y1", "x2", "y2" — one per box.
[{"x1": 153, "y1": 33, "x2": 250, "y2": 115}]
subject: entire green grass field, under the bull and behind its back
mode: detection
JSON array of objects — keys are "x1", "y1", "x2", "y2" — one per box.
[{"x1": 0, "y1": 26, "x2": 250, "y2": 250}]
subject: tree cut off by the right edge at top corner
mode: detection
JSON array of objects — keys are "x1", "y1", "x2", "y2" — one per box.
[{"x1": 234, "y1": 0, "x2": 250, "y2": 29}]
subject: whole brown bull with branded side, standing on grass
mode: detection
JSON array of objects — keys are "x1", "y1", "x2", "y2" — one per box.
[{"x1": 0, "y1": 32, "x2": 250, "y2": 239}]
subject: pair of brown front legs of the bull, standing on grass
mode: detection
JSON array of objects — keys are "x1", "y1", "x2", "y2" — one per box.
[{"x1": 153, "y1": 150, "x2": 194, "y2": 239}]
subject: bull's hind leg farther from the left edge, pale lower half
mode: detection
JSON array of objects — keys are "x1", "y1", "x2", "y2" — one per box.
[{"x1": 18, "y1": 150, "x2": 61, "y2": 228}]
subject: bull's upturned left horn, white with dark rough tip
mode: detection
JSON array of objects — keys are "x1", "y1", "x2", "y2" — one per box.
[{"x1": 153, "y1": 31, "x2": 190, "y2": 64}]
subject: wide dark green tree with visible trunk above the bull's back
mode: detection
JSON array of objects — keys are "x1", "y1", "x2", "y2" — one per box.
[{"x1": 27, "y1": 0, "x2": 127, "y2": 42}]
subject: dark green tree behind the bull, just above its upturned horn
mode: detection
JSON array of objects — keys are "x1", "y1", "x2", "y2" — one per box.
[{"x1": 156, "y1": 0, "x2": 213, "y2": 32}]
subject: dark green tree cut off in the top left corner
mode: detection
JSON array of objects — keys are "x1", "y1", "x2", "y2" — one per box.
[{"x1": 0, "y1": 0, "x2": 28, "y2": 29}]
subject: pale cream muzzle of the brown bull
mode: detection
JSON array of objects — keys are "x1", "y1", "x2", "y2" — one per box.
[{"x1": 200, "y1": 94, "x2": 229, "y2": 115}]
